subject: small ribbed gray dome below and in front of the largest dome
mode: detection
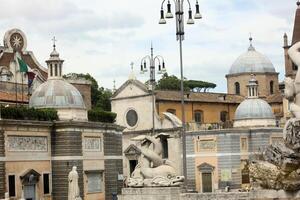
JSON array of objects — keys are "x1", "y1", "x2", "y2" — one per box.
[{"x1": 235, "y1": 98, "x2": 275, "y2": 120}]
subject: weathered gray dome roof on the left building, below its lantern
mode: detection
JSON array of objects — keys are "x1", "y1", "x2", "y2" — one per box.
[{"x1": 29, "y1": 78, "x2": 85, "y2": 109}]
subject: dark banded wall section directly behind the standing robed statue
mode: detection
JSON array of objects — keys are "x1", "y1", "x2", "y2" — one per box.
[{"x1": 52, "y1": 160, "x2": 83, "y2": 200}]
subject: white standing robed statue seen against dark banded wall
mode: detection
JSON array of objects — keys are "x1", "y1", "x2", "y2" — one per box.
[{"x1": 68, "y1": 166, "x2": 81, "y2": 200}]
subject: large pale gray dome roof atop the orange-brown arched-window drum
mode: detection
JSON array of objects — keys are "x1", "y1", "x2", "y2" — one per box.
[{"x1": 229, "y1": 45, "x2": 276, "y2": 74}]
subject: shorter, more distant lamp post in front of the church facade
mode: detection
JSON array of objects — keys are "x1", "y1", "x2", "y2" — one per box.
[{"x1": 141, "y1": 44, "x2": 166, "y2": 135}]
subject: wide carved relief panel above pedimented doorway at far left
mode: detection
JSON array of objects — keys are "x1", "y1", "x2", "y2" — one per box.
[{"x1": 7, "y1": 136, "x2": 48, "y2": 151}]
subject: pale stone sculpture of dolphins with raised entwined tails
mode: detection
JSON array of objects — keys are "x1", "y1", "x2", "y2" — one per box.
[{"x1": 128, "y1": 134, "x2": 184, "y2": 187}]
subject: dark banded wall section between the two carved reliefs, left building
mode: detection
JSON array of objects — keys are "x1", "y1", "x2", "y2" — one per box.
[{"x1": 51, "y1": 131, "x2": 82, "y2": 156}]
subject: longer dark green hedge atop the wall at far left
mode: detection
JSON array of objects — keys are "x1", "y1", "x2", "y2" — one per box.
[{"x1": 1, "y1": 106, "x2": 58, "y2": 121}]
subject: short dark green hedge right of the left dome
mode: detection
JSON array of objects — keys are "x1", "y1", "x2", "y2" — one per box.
[{"x1": 88, "y1": 109, "x2": 117, "y2": 123}]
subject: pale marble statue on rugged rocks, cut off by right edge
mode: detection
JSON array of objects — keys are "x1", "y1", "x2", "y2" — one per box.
[{"x1": 249, "y1": 42, "x2": 300, "y2": 191}]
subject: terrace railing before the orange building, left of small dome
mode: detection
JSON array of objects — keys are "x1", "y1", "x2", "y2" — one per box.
[{"x1": 186, "y1": 121, "x2": 233, "y2": 131}]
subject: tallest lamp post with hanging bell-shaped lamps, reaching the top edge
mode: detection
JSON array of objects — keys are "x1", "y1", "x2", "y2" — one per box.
[{"x1": 159, "y1": 0, "x2": 202, "y2": 186}]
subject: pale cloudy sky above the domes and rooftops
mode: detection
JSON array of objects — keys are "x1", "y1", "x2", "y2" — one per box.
[{"x1": 0, "y1": 0, "x2": 297, "y2": 92}]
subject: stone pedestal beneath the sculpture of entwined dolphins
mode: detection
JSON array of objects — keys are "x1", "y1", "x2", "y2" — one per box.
[{"x1": 119, "y1": 187, "x2": 181, "y2": 200}]
